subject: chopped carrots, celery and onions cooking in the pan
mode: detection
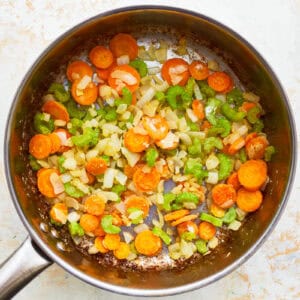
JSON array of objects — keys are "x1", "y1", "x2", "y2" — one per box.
[{"x1": 29, "y1": 33, "x2": 275, "y2": 260}]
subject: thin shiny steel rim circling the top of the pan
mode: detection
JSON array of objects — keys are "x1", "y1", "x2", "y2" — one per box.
[{"x1": 4, "y1": 5, "x2": 297, "y2": 297}]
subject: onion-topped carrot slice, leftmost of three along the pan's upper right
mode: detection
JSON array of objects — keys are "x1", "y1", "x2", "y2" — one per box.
[{"x1": 161, "y1": 58, "x2": 190, "y2": 86}]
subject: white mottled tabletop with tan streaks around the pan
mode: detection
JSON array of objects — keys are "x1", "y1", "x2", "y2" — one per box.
[{"x1": 0, "y1": 0, "x2": 300, "y2": 300}]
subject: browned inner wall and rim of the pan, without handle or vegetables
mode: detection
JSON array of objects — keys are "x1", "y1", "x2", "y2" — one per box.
[{"x1": 6, "y1": 8, "x2": 294, "y2": 294}]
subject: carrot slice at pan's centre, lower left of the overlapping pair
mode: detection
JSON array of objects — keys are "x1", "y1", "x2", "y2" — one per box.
[{"x1": 124, "y1": 128, "x2": 150, "y2": 153}]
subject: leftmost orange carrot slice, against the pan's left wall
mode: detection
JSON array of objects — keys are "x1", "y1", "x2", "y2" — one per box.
[{"x1": 29, "y1": 134, "x2": 52, "y2": 159}]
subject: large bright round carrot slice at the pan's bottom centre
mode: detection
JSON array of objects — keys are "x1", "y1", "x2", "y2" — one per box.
[{"x1": 134, "y1": 230, "x2": 162, "y2": 256}]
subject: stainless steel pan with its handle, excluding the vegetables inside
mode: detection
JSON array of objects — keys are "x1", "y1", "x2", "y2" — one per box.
[{"x1": 0, "y1": 6, "x2": 296, "y2": 299}]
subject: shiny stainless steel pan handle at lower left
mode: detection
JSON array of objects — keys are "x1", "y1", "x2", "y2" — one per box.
[{"x1": 0, "y1": 237, "x2": 53, "y2": 299}]
